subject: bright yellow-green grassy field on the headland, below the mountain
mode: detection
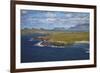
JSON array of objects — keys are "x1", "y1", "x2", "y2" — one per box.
[{"x1": 46, "y1": 32, "x2": 89, "y2": 44}]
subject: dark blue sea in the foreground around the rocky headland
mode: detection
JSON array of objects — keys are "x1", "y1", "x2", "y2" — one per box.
[{"x1": 21, "y1": 34, "x2": 89, "y2": 63}]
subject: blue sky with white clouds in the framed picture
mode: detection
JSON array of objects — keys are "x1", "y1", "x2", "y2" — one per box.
[{"x1": 21, "y1": 9, "x2": 90, "y2": 29}]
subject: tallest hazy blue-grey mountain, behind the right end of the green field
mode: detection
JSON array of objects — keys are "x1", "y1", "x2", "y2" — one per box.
[{"x1": 68, "y1": 24, "x2": 89, "y2": 32}]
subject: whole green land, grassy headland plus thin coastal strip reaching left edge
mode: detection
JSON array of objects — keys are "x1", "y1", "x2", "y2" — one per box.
[{"x1": 21, "y1": 29, "x2": 89, "y2": 45}]
